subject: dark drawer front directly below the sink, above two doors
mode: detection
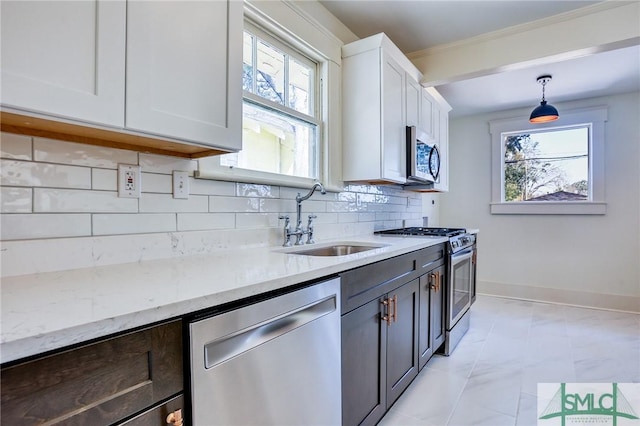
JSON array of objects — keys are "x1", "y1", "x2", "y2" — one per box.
[{"x1": 340, "y1": 253, "x2": 416, "y2": 314}]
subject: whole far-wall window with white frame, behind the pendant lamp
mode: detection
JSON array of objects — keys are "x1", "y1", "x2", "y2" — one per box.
[{"x1": 490, "y1": 108, "x2": 607, "y2": 214}]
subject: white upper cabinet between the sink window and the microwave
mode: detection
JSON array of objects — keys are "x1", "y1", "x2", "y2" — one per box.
[{"x1": 342, "y1": 34, "x2": 421, "y2": 184}]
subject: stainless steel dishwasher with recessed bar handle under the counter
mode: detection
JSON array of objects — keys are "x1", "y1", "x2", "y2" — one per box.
[{"x1": 189, "y1": 278, "x2": 342, "y2": 426}]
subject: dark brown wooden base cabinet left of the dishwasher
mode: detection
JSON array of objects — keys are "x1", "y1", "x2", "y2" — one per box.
[{"x1": 0, "y1": 320, "x2": 184, "y2": 425}]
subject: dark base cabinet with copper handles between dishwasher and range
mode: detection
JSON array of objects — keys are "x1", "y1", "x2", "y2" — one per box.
[{"x1": 341, "y1": 245, "x2": 444, "y2": 426}]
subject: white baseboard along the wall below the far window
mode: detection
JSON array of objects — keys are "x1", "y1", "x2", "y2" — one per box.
[{"x1": 477, "y1": 281, "x2": 640, "y2": 313}]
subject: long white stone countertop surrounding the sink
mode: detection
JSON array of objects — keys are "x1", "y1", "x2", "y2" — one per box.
[{"x1": 0, "y1": 235, "x2": 448, "y2": 363}]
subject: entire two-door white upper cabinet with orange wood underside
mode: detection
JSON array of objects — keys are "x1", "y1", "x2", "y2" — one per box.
[{"x1": 0, "y1": 0, "x2": 243, "y2": 155}]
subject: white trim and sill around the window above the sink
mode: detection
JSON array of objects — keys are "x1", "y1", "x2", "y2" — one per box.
[{"x1": 196, "y1": 2, "x2": 344, "y2": 191}]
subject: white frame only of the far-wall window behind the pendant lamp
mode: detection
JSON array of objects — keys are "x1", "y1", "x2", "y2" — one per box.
[{"x1": 489, "y1": 107, "x2": 607, "y2": 215}]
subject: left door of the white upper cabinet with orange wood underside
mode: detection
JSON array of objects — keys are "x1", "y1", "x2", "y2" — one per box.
[{"x1": 0, "y1": 0, "x2": 126, "y2": 127}]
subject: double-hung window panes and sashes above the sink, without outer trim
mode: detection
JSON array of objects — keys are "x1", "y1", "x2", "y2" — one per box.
[{"x1": 220, "y1": 24, "x2": 319, "y2": 179}]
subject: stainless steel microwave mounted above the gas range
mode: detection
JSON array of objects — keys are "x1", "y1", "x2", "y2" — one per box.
[{"x1": 407, "y1": 126, "x2": 440, "y2": 183}]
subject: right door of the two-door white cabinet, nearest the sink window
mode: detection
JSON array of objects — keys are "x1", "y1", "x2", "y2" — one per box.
[{"x1": 126, "y1": 0, "x2": 243, "y2": 150}]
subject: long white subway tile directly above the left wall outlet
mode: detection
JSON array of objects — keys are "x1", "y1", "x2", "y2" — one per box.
[{"x1": 33, "y1": 138, "x2": 138, "y2": 169}]
